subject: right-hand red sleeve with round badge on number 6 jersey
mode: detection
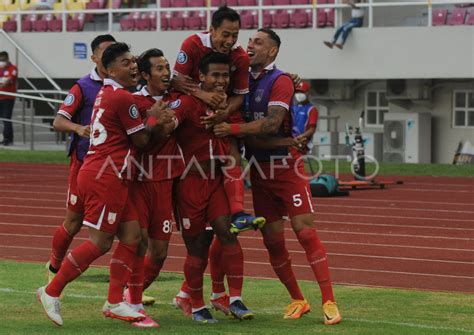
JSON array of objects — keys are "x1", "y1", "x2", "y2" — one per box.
[{"x1": 116, "y1": 91, "x2": 145, "y2": 135}]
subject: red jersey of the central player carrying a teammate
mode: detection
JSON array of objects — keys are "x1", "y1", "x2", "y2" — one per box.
[{"x1": 174, "y1": 95, "x2": 229, "y2": 164}]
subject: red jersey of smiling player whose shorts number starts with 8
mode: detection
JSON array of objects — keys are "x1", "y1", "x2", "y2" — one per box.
[{"x1": 134, "y1": 86, "x2": 185, "y2": 181}]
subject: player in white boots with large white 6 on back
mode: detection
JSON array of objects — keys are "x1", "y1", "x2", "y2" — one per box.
[{"x1": 37, "y1": 43, "x2": 171, "y2": 325}]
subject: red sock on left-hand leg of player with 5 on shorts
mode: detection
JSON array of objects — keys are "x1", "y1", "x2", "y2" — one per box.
[{"x1": 263, "y1": 232, "x2": 304, "y2": 300}]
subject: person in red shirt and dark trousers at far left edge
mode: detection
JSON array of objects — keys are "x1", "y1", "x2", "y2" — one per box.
[{"x1": 0, "y1": 51, "x2": 17, "y2": 146}]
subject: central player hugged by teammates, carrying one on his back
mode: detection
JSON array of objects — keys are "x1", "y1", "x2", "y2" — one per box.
[{"x1": 170, "y1": 53, "x2": 253, "y2": 323}]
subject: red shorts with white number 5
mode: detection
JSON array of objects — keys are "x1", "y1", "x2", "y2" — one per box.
[{"x1": 250, "y1": 160, "x2": 314, "y2": 222}]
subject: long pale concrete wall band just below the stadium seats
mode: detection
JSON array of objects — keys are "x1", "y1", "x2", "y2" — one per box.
[{"x1": 0, "y1": 26, "x2": 474, "y2": 79}]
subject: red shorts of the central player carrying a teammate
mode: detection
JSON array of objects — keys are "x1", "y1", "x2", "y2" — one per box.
[{"x1": 176, "y1": 171, "x2": 230, "y2": 236}]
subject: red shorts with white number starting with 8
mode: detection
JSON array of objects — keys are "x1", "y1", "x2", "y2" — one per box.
[{"x1": 130, "y1": 180, "x2": 173, "y2": 241}]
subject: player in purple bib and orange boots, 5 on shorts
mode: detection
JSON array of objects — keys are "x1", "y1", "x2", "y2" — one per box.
[{"x1": 214, "y1": 29, "x2": 341, "y2": 324}]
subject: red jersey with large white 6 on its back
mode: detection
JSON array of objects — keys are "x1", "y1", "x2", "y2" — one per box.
[{"x1": 82, "y1": 79, "x2": 145, "y2": 179}]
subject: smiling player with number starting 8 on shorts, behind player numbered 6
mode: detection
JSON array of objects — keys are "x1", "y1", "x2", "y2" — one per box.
[{"x1": 124, "y1": 49, "x2": 185, "y2": 328}]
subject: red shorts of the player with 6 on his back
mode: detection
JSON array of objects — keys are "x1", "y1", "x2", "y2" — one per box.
[{"x1": 77, "y1": 170, "x2": 137, "y2": 234}]
